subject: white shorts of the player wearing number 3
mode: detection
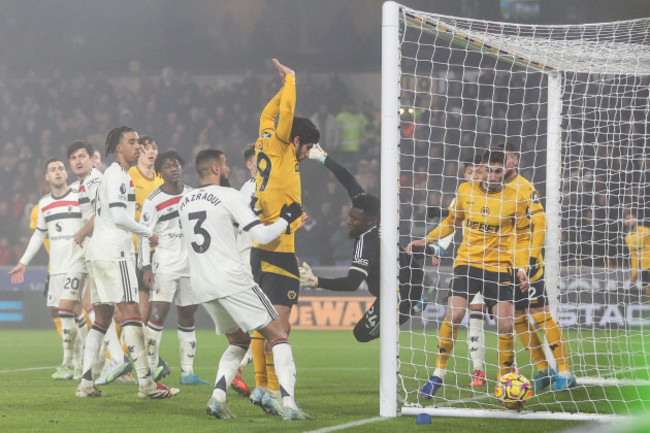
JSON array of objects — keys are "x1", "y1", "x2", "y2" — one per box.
[{"x1": 203, "y1": 284, "x2": 278, "y2": 335}]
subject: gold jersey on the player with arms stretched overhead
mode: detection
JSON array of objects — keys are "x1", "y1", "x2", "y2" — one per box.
[{"x1": 253, "y1": 75, "x2": 301, "y2": 253}]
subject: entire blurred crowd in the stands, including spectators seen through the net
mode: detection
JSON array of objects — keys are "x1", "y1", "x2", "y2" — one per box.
[{"x1": 0, "y1": 68, "x2": 650, "y2": 265}]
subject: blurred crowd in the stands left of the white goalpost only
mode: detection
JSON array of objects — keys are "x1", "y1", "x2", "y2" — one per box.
[{"x1": 0, "y1": 68, "x2": 379, "y2": 265}]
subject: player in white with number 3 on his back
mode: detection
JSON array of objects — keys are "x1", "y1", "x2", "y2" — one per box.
[{"x1": 179, "y1": 149, "x2": 310, "y2": 420}]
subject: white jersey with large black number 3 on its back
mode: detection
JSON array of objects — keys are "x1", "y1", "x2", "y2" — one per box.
[{"x1": 179, "y1": 185, "x2": 261, "y2": 302}]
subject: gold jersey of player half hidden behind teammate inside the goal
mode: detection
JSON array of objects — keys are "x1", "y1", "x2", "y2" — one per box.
[{"x1": 506, "y1": 174, "x2": 546, "y2": 282}]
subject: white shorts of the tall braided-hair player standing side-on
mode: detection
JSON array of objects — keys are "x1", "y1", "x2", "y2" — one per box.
[{"x1": 87, "y1": 260, "x2": 138, "y2": 305}]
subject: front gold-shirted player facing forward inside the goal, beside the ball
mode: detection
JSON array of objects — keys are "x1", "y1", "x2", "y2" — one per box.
[{"x1": 412, "y1": 151, "x2": 529, "y2": 399}]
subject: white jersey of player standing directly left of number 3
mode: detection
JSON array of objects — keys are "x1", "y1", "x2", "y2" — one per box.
[{"x1": 138, "y1": 186, "x2": 191, "y2": 277}]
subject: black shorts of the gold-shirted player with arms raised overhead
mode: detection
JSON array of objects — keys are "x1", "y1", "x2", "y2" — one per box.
[{"x1": 251, "y1": 248, "x2": 300, "y2": 307}]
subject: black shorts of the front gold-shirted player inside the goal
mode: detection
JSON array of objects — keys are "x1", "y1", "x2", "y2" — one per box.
[{"x1": 451, "y1": 265, "x2": 515, "y2": 309}]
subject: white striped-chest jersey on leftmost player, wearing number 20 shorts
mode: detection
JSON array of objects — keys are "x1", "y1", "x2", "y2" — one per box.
[{"x1": 36, "y1": 189, "x2": 86, "y2": 275}]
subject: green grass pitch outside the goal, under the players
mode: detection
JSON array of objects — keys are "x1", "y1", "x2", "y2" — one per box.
[{"x1": 0, "y1": 329, "x2": 644, "y2": 433}]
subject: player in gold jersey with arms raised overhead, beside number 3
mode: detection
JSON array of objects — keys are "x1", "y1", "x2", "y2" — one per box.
[{"x1": 251, "y1": 59, "x2": 320, "y2": 415}]
